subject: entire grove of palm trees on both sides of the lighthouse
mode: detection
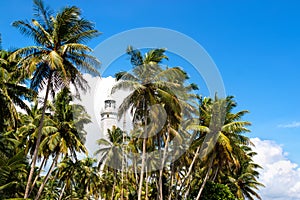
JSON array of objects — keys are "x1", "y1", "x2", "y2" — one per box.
[{"x1": 0, "y1": 0, "x2": 262, "y2": 200}]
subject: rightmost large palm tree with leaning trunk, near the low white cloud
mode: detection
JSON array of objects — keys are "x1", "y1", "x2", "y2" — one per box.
[{"x1": 182, "y1": 96, "x2": 250, "y2": 199}]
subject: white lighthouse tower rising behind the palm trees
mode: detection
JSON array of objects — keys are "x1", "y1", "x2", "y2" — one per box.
[{"x1": 100, "y1": 98, "x2": 117, "y2": 136}]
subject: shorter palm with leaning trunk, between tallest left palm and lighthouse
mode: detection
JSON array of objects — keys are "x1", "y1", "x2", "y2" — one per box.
[{"x1": 36, "y1": 87, "x2": 90, "y2": 199}]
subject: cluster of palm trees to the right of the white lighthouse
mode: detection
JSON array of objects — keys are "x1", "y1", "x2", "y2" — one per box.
[{"x1": 96, "y1": 46, "x2": 263, "y2": 200}]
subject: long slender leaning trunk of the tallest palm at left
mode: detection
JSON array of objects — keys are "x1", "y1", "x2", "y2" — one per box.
[{"x1": 24, "y1": 72, "x2": 53, "y2": 199}]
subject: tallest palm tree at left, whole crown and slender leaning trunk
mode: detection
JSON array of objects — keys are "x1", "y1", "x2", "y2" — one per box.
[{"x1": 11, "y1": 0, "x2": 99, "y2": 198}]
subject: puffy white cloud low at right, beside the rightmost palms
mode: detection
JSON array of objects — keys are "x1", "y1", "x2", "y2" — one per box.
[{"x1": 251, "y1": 138, "x2": 300, "y2": 200}]
